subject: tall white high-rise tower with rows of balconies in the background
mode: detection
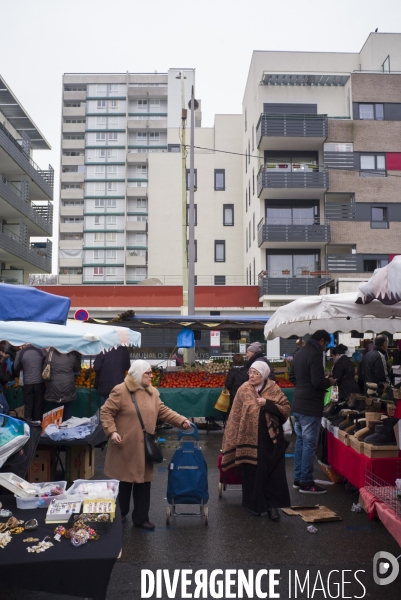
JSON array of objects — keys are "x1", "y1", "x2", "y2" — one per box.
[{"x1": 59, "y1": 69, "x2": 206, "y2": 284}]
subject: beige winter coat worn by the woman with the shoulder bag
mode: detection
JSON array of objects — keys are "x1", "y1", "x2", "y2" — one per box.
[{"x1": 100, "y1": 375, "x2": 186, "y2": 483}]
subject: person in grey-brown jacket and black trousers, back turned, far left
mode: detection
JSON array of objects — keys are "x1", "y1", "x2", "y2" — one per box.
[{"x1": 14, "y1": 344, "x2": 46, "y2": 421}]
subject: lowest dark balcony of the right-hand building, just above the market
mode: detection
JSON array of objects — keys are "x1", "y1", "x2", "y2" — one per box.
[{"x1": 258, "y1": 271, "x2": 330, "y2": 298}]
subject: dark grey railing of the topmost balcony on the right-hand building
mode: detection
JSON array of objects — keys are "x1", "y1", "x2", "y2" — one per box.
[{"x1": 256, "y1": 113, "x2": 328, "y2": 146}]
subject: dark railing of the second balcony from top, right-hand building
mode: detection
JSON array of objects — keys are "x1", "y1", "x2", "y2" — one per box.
[{"x1": 258, "y1": 163, "x2": 329, "y2": 196}]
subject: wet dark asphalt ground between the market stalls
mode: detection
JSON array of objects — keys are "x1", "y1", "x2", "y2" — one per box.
[{"x1": 0, "y1": 429, "x2": 401, "y2": 600}]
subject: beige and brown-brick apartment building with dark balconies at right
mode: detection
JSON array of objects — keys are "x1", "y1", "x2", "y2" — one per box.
[{"x1": 243, "y1": 33, "x2": 401, "y2": 310}]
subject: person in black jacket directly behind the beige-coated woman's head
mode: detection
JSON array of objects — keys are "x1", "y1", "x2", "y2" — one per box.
[{"x1": 93, "y1": 346, "x2": 131, "y2": 405}]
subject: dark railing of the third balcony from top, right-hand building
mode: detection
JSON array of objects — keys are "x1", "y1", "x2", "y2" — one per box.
[{"x1": 258, "y1": 219, "x2": 330, "y2": 247}]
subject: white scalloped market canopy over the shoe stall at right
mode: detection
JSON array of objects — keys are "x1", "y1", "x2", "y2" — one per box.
[{"x1": 264, "y1": 292, "x2": 401, "y2": 340}]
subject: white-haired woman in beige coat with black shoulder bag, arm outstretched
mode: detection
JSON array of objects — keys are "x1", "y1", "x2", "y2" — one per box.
[{"x1": 100, "y1": 360, "x2": 191, "y2": 530}]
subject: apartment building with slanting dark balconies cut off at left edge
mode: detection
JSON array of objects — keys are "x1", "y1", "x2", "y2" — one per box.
[{"x1": 0, "y1": 76, "x2": 54, "y2": 284}]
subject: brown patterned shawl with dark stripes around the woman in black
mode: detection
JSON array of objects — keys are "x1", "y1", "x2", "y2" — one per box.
[{"x1": 221, "y1": 379, "x2": 291, "y2": 471}]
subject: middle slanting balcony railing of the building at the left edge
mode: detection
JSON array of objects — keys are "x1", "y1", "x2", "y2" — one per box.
[{"x1": 0, "y1": 173, "x2": 53, "y2": 235}]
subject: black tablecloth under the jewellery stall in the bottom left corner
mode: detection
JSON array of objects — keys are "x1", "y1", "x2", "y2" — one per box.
[{"x1": 0, "y1": 496, "x2": 122, "y2": 600}]
